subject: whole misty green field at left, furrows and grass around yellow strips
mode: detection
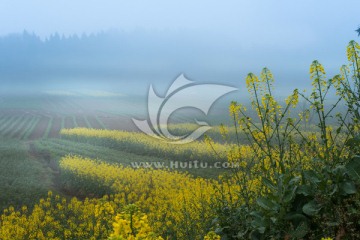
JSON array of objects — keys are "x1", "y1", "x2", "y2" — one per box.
[{"x1": 0, "y1": 95, "x2": 231, "y2": 209}]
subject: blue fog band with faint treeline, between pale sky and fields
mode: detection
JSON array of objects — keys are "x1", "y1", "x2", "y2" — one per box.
[{"x1": 0, "y1": 30, "x2": 354, "y2": 99}]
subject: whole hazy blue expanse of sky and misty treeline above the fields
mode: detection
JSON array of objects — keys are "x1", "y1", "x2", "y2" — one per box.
[{"x1": 0, "y1": 0, "x2": 360, "y2": 95}]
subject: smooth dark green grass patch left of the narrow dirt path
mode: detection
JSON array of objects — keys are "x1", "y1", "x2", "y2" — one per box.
[{"x1": 0, "y1": 138, "x2": 52, "y2": 209}]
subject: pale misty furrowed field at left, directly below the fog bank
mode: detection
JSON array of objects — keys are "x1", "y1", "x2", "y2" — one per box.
[{"x1": 0, "y1": 96, "x2": 148, "y2": 140}]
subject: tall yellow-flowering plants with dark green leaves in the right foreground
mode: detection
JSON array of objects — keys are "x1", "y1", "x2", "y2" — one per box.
[{"x1": 208, "y1": 41, "x2": 360, "y2": 239}]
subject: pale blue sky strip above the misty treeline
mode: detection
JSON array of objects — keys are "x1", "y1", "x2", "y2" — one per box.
[{"x1": 0, "y1": 0, "x2": 360, "y2": 40}]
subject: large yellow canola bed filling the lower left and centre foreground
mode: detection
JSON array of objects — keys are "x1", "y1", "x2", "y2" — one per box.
[{"x1": 0, "y1": 156, "x2": 239, "y2": 240}]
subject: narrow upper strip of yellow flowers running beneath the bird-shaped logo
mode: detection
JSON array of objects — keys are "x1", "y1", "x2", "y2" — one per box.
[{"x1": 60, "y1": 128, "x2": 228, "y2": 162}]
